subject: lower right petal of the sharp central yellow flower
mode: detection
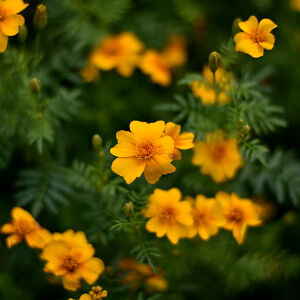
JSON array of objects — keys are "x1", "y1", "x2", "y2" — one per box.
[{"x1": 144, "y1": 154, "x2": 176, "y2": 184}]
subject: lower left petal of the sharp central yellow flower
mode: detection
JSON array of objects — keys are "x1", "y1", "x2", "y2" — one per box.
[{"x1": 111, "y1": 157, "x2": 146, "y2": 184}]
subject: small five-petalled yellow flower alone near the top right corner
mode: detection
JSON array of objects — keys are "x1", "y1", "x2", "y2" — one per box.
[{"x1": 234, "y1": 16, "x2": 277, "y2": 58}]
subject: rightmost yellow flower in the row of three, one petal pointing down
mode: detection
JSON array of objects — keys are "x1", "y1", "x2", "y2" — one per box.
[{"x1": 216, "y1": 192, "x2": 261, "y2": 244}]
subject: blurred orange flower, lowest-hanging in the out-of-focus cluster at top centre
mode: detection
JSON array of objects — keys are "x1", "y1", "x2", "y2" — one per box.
[{"x1": 140, "y1": 50, "x2": 172, "y2": 87}]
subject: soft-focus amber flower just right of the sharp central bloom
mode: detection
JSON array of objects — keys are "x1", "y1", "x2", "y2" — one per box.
[{"x1": 192, "y1": 130, "x2": 243, "y2": 182}]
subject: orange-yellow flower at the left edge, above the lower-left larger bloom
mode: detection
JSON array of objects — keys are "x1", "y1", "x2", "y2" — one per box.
[{"x1": 0, "y1": 207, "x2": 51, "y2": 249}]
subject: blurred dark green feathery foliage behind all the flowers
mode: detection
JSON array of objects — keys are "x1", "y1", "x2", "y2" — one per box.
[{"x1": 0, "y1": 0, "x2": 300, "y2": 300}]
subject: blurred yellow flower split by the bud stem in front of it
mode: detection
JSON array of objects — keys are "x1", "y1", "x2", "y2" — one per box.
[{"x1": 190, "y1": 65, "x2": 233, "y2": 105}]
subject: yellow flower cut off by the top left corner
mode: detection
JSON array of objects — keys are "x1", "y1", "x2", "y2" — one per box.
[{"x1": 0, "y1": 0, "x2": 29, "y2": 52}]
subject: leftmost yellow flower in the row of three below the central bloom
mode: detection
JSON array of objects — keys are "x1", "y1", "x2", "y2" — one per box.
[{"x1": 143, "y1": 188, "x2": 193, "y2": 244}]
